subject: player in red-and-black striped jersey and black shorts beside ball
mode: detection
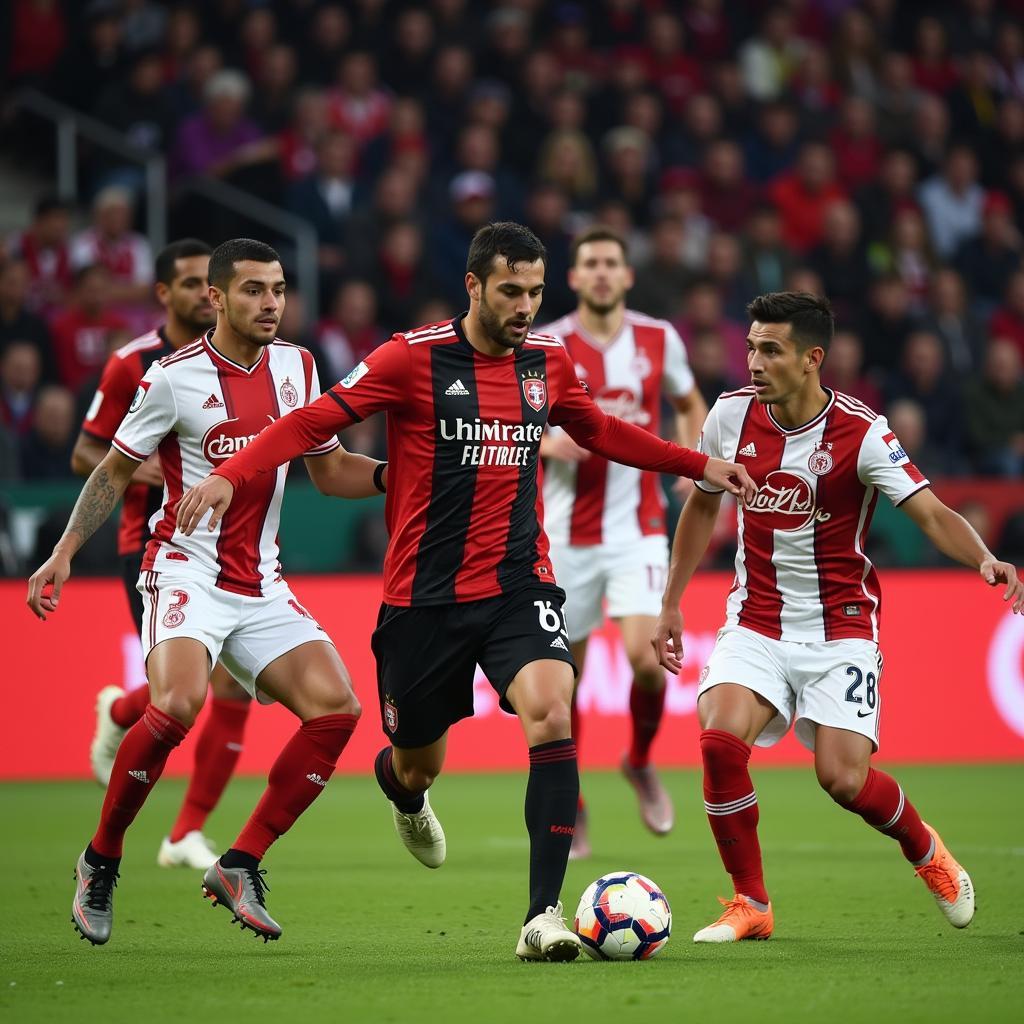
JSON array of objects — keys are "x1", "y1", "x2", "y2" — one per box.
[{"x1": 178, "y1": 222, "x2": 754, "y2": 961}]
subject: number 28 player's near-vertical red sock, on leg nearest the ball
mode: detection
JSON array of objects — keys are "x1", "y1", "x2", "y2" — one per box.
[{"x1": 700, "y1": 729, "x2": 768, "y2": 903}]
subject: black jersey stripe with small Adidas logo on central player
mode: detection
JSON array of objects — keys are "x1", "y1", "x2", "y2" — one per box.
[{"x1": 412, "y1": 339, "x2": 480, "y2": 604}]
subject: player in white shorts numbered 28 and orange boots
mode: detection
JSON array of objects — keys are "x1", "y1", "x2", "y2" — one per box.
[{"x1": 653, "y1": 292, "x2": 1024, "y2": 942}]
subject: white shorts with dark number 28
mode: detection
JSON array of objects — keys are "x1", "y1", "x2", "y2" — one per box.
[{"x1": 697, "y1": 626, "x2": 882, "y2": 751}]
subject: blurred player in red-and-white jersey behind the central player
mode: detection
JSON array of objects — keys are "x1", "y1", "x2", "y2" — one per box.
[{"x1": 541, "y1": 226, "x2": 708, "y2": 860}]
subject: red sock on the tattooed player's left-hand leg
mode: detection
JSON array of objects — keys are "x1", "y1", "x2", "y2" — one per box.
[{"x1": 92, "y1": 705, "x2": 188, "y2": 857}]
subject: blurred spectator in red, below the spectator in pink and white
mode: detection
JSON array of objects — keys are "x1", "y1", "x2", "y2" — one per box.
[{"x1": 50, "y1": 263, "x2": 126, "y2": 393}]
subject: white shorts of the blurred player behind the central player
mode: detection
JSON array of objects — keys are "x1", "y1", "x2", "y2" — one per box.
[{"x1": 551, "y1": 537, "x2": 669, "y2": 643}]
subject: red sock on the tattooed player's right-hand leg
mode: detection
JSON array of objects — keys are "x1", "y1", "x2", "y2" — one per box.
[{"x1": 231, "y1": 715, "x2": 358, "y2": 860}]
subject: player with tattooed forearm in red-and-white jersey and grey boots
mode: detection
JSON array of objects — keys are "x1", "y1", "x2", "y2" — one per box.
[{"x1": 28, "y1": 239, "x2": 385, "y2": 945}]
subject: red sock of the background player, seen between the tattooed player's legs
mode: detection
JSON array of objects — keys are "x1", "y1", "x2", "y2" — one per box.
[{"x1": 171, "y1": 697, "x2": 252, "y2": 843}]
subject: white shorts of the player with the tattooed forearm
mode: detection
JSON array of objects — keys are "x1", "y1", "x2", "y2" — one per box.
[{"x1": 138, "y1": 570, "x2": 332, "y2": 703}]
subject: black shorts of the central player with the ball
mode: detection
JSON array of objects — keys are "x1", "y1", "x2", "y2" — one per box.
[{"x1": 371, "y1": 584, "x2": 577, "y2": 748}]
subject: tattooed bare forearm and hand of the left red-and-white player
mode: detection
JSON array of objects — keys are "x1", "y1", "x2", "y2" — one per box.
[{"x1": 27, "y1": 449, "x2": 138, "y2": 620}]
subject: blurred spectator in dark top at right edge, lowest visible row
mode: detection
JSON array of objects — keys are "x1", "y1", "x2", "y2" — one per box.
[{"x1": 964, "y1": 338, "x2": 1024, "y2": 477}]
